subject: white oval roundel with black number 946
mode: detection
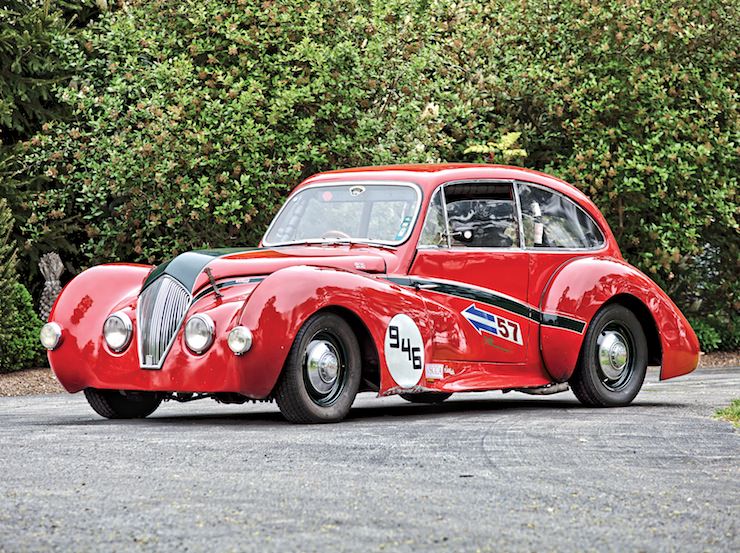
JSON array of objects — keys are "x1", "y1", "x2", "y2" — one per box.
[{"x1": 385, "y1": 313, "x2": 424, "y2": 388}]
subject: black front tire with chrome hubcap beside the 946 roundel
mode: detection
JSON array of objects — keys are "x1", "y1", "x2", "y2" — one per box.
[{"x1": 275, "y1": 313, "x2": 362, "y2": 424}]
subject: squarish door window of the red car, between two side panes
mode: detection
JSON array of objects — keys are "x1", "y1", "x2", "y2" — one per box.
[{"x1": 444, "y1": 184, "x2": 519, "y2": 248}]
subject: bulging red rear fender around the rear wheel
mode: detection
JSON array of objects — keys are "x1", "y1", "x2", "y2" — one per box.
[{"x1": 540, "y1": 257, "x2": 699, "y2": 381}]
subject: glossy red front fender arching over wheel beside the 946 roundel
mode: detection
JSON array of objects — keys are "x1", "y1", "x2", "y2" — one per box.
[{"x1": 239, "y1": 266, "x2": 432, "y2": 395}]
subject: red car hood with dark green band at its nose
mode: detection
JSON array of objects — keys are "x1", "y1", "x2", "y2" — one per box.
[{"x1": 142, "y1": 245, "x2": 394, "y2": 292}]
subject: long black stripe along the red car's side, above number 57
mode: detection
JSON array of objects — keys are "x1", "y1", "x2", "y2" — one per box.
[{"x1": 386, "y1": 277, "x2": 586, "y2": 333}]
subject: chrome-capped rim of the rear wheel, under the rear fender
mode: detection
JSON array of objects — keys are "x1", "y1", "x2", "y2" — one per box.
[{"x1": 596, "y1": 323, "x2": 635, "y2": 392}]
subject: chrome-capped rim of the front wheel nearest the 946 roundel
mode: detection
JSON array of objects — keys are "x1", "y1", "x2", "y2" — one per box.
[{"x1": 303, "y1": 332, "x2": 347, "y2": 406}]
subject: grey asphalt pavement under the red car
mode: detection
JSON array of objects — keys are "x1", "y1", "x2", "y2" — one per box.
[{"x1": 0, "y1": 367, "x2": 740, "y2": 552}]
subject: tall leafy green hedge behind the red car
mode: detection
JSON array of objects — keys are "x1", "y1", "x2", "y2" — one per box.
[{"x1": 7, "y1": 0, "x2": 740, "y2": 349}]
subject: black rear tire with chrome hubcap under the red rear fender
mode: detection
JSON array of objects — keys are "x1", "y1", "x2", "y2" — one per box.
[{"x1": 569, "y1": 304, "x2": 648, "y2": 407}]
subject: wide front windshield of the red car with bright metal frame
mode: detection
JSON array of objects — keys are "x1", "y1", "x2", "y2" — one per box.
[{"x1": 263, "y1": 184, "x2": 421, "y2": 246}]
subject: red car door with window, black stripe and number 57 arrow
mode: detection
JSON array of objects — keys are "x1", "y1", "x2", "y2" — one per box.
[{"x1": 409, "y1": 182, "x2": 533, "y2": 363}]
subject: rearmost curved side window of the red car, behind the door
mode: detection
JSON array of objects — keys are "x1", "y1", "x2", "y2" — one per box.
[{"x1": 519, "y1": 184, "x2": 604, "y2": 249}]
